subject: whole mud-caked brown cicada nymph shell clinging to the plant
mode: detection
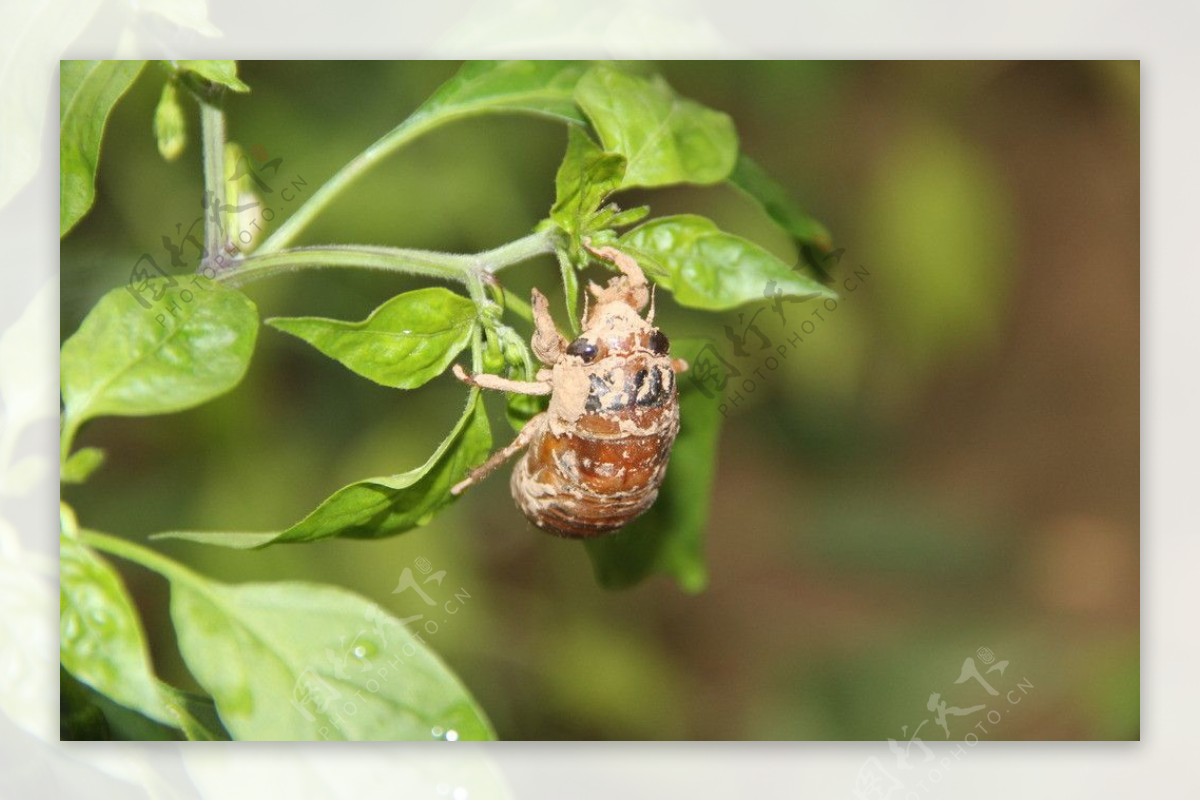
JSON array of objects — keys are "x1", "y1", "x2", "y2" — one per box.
[{"x1": 451, "y1": 241, "x2": 688, "y2": 537}]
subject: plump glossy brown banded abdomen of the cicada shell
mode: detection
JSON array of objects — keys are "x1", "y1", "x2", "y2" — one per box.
[{"x1": 512, "y1": 404, "x2": 679, "y2": 537}]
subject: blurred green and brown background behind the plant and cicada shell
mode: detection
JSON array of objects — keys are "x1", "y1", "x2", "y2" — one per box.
[{"x1": 61, "y1": 61, "x2": 1139, "y2": 740}]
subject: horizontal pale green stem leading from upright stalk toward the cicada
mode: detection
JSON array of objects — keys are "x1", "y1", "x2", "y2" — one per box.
[{"x1": 217, "y1": 231, "x2": 557, "y2": 288}]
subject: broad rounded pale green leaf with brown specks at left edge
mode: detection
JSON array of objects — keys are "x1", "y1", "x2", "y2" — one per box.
[{"x1": 61, "y1": 276, "x2": 258, "y2": 444}]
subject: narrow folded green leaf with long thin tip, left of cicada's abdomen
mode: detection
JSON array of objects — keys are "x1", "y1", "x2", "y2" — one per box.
[{"x1": 155, "y1": 390, "x2": 492, "y2": 548}]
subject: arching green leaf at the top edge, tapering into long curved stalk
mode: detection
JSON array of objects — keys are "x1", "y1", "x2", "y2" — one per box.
[{"x1": 412, "y1": 61, "x2": 588, "y2": 133}]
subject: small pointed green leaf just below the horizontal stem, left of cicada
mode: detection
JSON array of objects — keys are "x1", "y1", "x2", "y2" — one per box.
[{"x1": 266, "y1": 287, "x2": 476, "y2": 390}]
